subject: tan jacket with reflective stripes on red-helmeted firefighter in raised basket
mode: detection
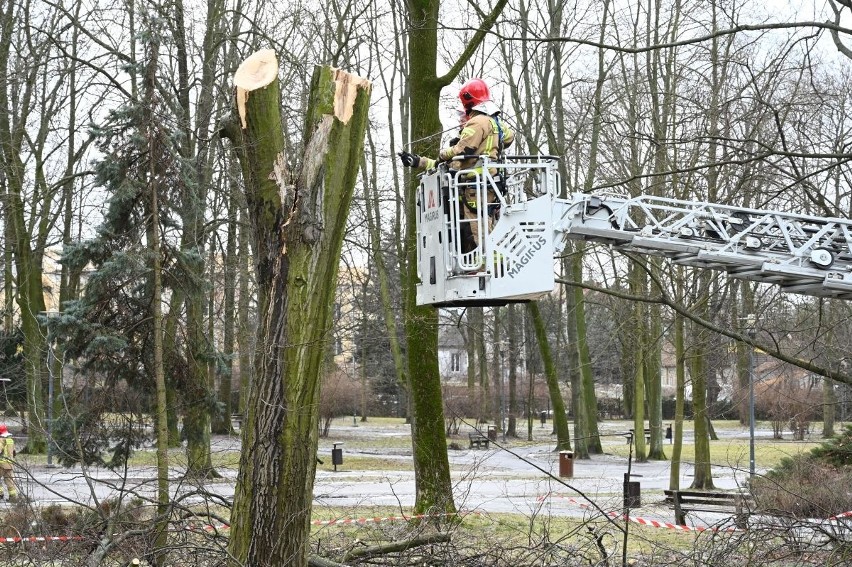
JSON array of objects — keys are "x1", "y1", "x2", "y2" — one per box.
[{"x1": 417, "y1": 110, "x2": 515, "y2": 169}]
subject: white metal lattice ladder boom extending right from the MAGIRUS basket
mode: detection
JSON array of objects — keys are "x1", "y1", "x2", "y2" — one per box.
[{"x1": 554, "y1": 193, "x2": 852, "y2": 299}]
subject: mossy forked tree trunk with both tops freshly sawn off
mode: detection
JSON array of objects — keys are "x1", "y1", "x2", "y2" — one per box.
[{"x1": 225, "y1": 54, "x2": 370, "y2": 567}]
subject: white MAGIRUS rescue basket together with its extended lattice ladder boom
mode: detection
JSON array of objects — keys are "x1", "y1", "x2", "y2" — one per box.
[{"x1": 416, "y1": 156, "x2": 852, "y2": 307}]
